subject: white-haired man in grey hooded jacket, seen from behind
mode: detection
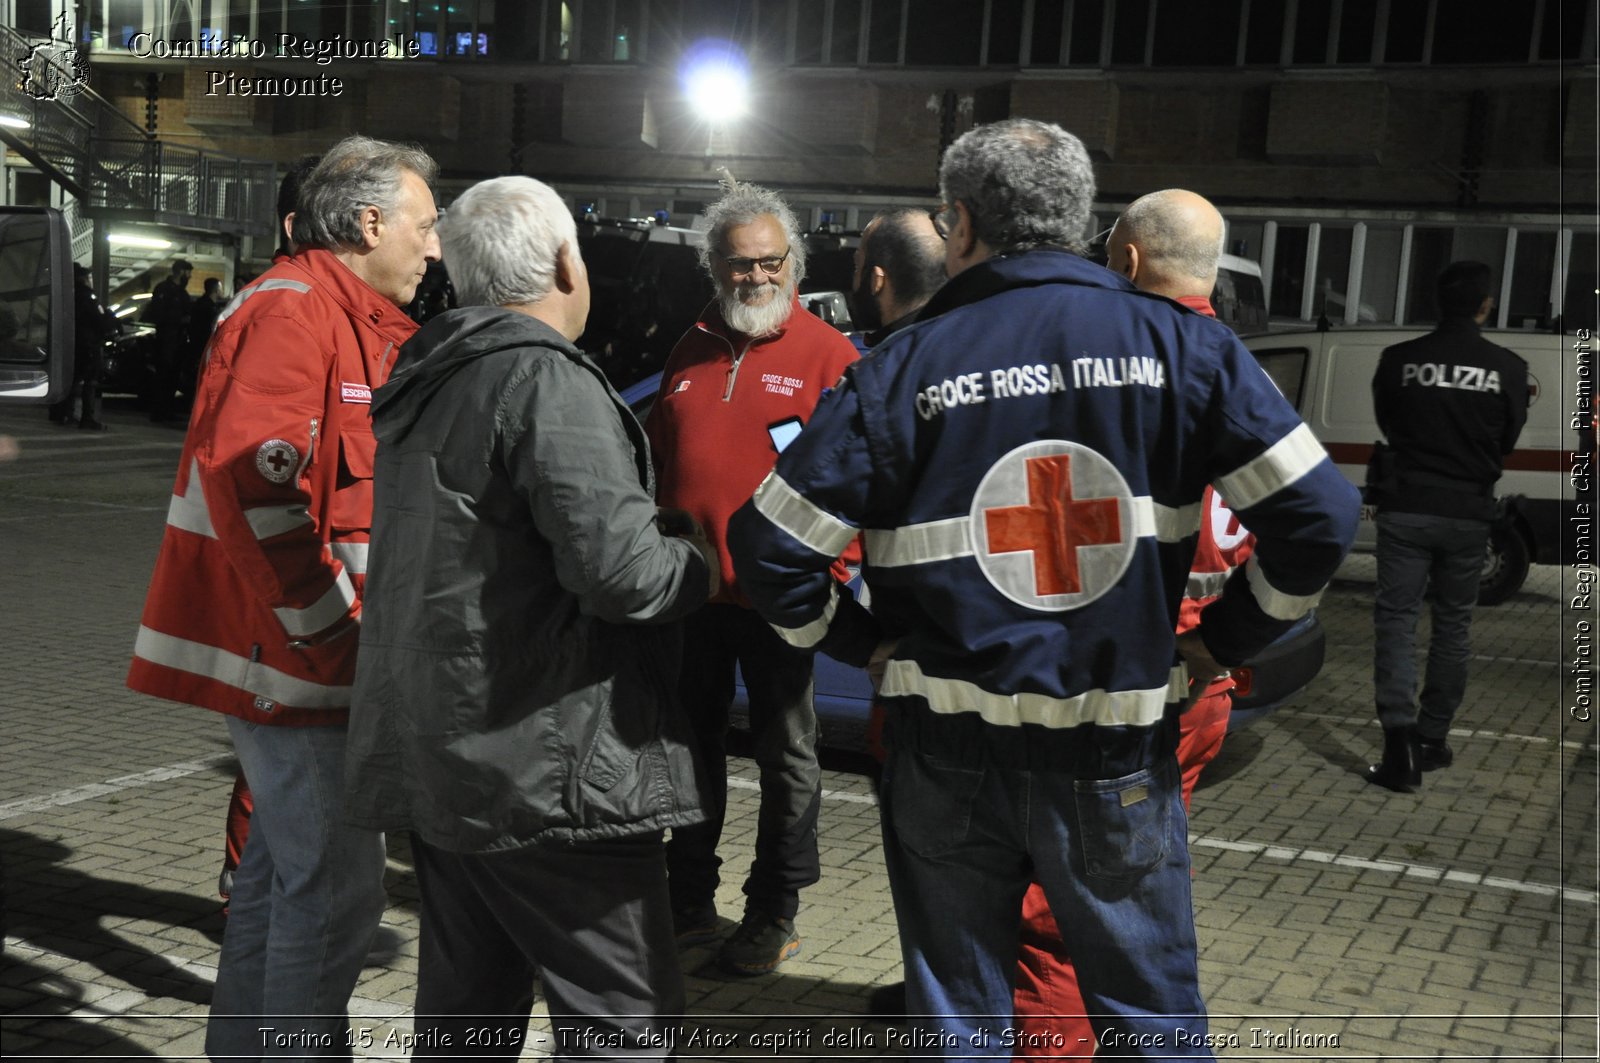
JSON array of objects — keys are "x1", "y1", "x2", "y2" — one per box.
[{"x1": 346, "y1": 178, "x2": 718, "y2": 1060}]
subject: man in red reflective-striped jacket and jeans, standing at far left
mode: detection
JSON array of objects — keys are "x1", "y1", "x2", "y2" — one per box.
[{"x1": 128, "y1": 136, "x2": 438, "y2": 1058}]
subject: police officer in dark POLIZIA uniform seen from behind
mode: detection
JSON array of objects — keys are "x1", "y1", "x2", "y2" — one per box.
[{"x1": 1366, "y1": 263, "x2": 1528, "y2": 792}]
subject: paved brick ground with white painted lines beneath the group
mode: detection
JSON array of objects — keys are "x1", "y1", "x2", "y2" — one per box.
[{"x1": 0, "y1": 405, "x2": 1600, "y2": 1060}]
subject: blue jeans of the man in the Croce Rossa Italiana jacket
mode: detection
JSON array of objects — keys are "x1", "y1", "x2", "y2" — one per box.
[{"x1": 878, "y1": 736, "x2": 1213, "y2": 1060}]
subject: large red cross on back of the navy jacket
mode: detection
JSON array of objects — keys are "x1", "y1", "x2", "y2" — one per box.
[{"x1": 984, "y1": 455, "x2": 1122, "y2": 597}]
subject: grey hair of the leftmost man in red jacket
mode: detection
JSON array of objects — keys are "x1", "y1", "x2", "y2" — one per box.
[{"x1": 294, "y1": 134, "x2": 438, "y2": 250}]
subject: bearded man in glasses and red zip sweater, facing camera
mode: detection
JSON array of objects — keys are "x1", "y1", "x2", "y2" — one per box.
[{"x1": 646, "y1": 184, "x2": 856, "y2": 975}]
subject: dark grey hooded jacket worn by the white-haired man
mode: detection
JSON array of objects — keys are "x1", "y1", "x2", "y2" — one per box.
[{"x1": 346, "y1": 307, "x2": 710, "y2": 853}]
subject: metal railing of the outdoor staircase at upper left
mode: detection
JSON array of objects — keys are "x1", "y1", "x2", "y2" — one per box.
[{"x1": 0, "y1": 26, "x2": 277, "y2": 235}]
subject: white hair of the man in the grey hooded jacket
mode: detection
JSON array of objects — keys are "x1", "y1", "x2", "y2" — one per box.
[{"x1": 438, "y1": 178, "x2": 578, "y2": 306}]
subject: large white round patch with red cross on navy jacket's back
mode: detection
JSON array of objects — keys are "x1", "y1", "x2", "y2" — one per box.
[{"x1": 971, "y1": 439, "x2": 1138, "y2": 613}]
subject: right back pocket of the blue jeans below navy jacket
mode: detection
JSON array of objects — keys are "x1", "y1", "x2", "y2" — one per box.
[{"x1": 1072, "y1": 768, "x2": 1173, "y2": 879}]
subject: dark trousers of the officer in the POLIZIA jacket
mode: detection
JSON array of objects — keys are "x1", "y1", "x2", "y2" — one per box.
[{"x1": 1373, "y1": 512, "x2": 1490, "y2": 741}]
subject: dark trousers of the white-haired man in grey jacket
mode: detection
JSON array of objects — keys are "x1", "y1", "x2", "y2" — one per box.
[{"x1": 411, "y1": 831, "x2": 683, "y2": 1060}]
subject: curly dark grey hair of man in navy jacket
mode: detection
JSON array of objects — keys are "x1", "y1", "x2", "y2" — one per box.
[{"x1": 939, "y1": 118, "x2": 1094, "y2": 255}]
